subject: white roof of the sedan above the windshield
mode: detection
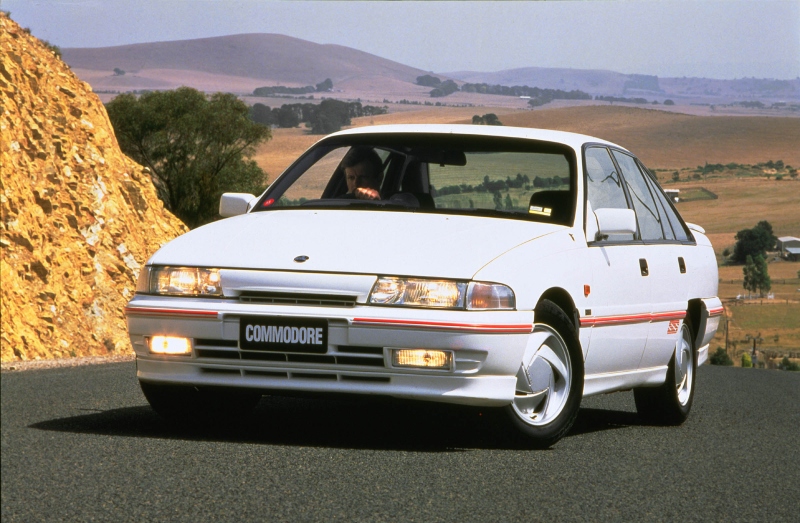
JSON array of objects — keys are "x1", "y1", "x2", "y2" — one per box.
[{"x1": 330, "y1": 124, "x2": 625, "y2": 151}]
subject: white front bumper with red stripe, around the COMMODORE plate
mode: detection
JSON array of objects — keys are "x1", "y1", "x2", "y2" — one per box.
[{"x1": 125, "y1": 295, "x2": 533, "y2": 406}]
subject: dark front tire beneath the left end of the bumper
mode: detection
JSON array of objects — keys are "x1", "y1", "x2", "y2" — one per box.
[{"x1": 139, "y1": 381, "x2": 261, "y2": 423}]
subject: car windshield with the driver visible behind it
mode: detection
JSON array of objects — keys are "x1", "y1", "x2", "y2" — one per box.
[{"x1": 254, "y1": 133, "x2": 575, "y2": 224}]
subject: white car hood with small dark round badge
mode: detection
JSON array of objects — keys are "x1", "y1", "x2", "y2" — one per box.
[{"x1": 148, "y1": 209, "x2": 563, "y2": 279}]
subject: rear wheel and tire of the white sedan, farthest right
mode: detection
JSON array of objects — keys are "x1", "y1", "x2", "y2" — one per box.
[{"x1": 633, "y1": 318, "x2": 697, "y2": 425}]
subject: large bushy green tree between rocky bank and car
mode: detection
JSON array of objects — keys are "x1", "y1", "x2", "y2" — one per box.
[{"x1": 106, "y1": 87, "x2": 270, "y2": 227}]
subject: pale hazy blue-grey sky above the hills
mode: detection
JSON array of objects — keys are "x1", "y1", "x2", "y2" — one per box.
[{"x1": 6, "y1": 0, "x2": 800, "y2": 79}]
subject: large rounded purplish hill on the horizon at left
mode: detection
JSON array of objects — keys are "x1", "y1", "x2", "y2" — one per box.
[{"x1": 62, "y1": 34, "x2": 432, "y2": 89}]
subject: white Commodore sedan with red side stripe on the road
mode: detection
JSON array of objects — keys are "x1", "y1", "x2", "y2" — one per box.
[{"x1": 125, "y1": 125, "x2": 723, "y2": 447}]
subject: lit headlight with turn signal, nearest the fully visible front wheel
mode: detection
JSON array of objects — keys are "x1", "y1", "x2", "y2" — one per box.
[{"x1": 369, "y1": 276, "x2": 516, "y2": 310}]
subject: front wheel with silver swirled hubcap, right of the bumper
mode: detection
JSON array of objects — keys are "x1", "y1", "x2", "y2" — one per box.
[{"x1": 506, "y1": 300, "x2": 583, "y2": 448}]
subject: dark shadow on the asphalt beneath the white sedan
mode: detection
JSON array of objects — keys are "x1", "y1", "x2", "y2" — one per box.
[{"x1": 29, "y1": 396, "x2": 641, "y2": 452}]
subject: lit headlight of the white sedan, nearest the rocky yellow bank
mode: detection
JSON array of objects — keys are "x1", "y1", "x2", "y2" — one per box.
[{"x1": 136, "y1": 267, "x2": 222, "y2": 296}]
